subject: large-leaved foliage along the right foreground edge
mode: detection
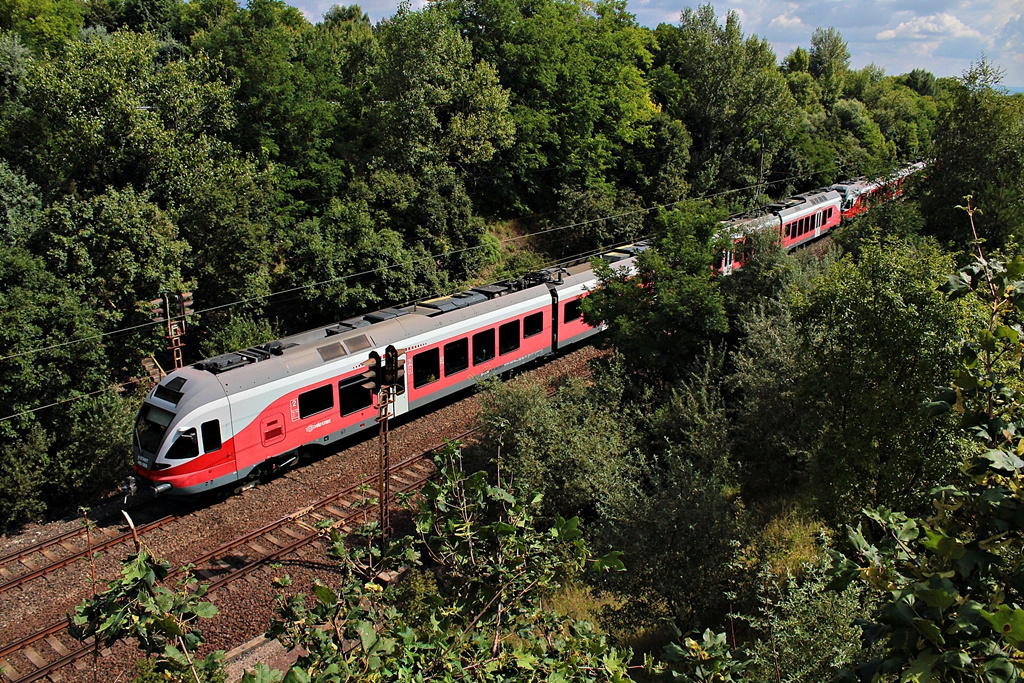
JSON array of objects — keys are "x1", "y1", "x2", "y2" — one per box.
[{"x1": 833, "y1": 248, "x2": 1024, "y2": 682}]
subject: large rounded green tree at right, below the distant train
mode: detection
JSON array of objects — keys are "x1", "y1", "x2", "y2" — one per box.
[{"x1": 792, "y1": 238, "x2": 971, "y2": 521}]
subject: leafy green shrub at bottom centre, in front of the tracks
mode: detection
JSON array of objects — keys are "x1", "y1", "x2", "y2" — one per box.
[{"x1": 264, "y1": 445, "x2": 629, "y2": 683}]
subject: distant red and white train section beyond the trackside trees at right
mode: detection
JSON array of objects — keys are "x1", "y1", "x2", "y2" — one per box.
[{"x1": 715, "y1": 162, "x2": 925, "y2": 274}]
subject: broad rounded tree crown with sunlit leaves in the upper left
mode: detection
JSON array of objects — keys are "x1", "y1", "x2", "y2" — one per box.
[{"x1": 0, "y1": 32, "x2": 232, "y2": 200}]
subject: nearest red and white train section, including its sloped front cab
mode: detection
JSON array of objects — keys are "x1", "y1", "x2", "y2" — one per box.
[{"x1": 132, "y1": 243, "x2": 646, "y2": 496}]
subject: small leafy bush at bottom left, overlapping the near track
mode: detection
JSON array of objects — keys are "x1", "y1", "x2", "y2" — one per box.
[{"x1": 68, "y1": 544, "x2": 224, "y2": 683}]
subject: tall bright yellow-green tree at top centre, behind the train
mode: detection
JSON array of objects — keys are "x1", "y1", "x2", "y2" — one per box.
[{"x1": 435, "y1": 0, "x2": 658, "y2": 212}]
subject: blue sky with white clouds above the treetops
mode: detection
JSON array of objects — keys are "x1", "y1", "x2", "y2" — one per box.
[{"x1": 289, "y1": 0, "x2": 1024, "y2": 88}]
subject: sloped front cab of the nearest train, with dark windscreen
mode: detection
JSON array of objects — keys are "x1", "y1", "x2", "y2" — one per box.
[{"x1": 132, "y1": 368, "x2": 237, "y2": 495}]
